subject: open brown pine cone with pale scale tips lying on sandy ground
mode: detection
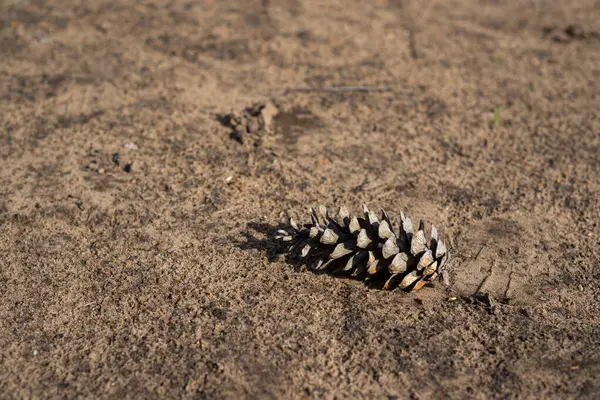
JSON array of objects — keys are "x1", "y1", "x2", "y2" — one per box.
[{"x1": 275, "y1": 206, "x2": 449, "y2": 291}]
